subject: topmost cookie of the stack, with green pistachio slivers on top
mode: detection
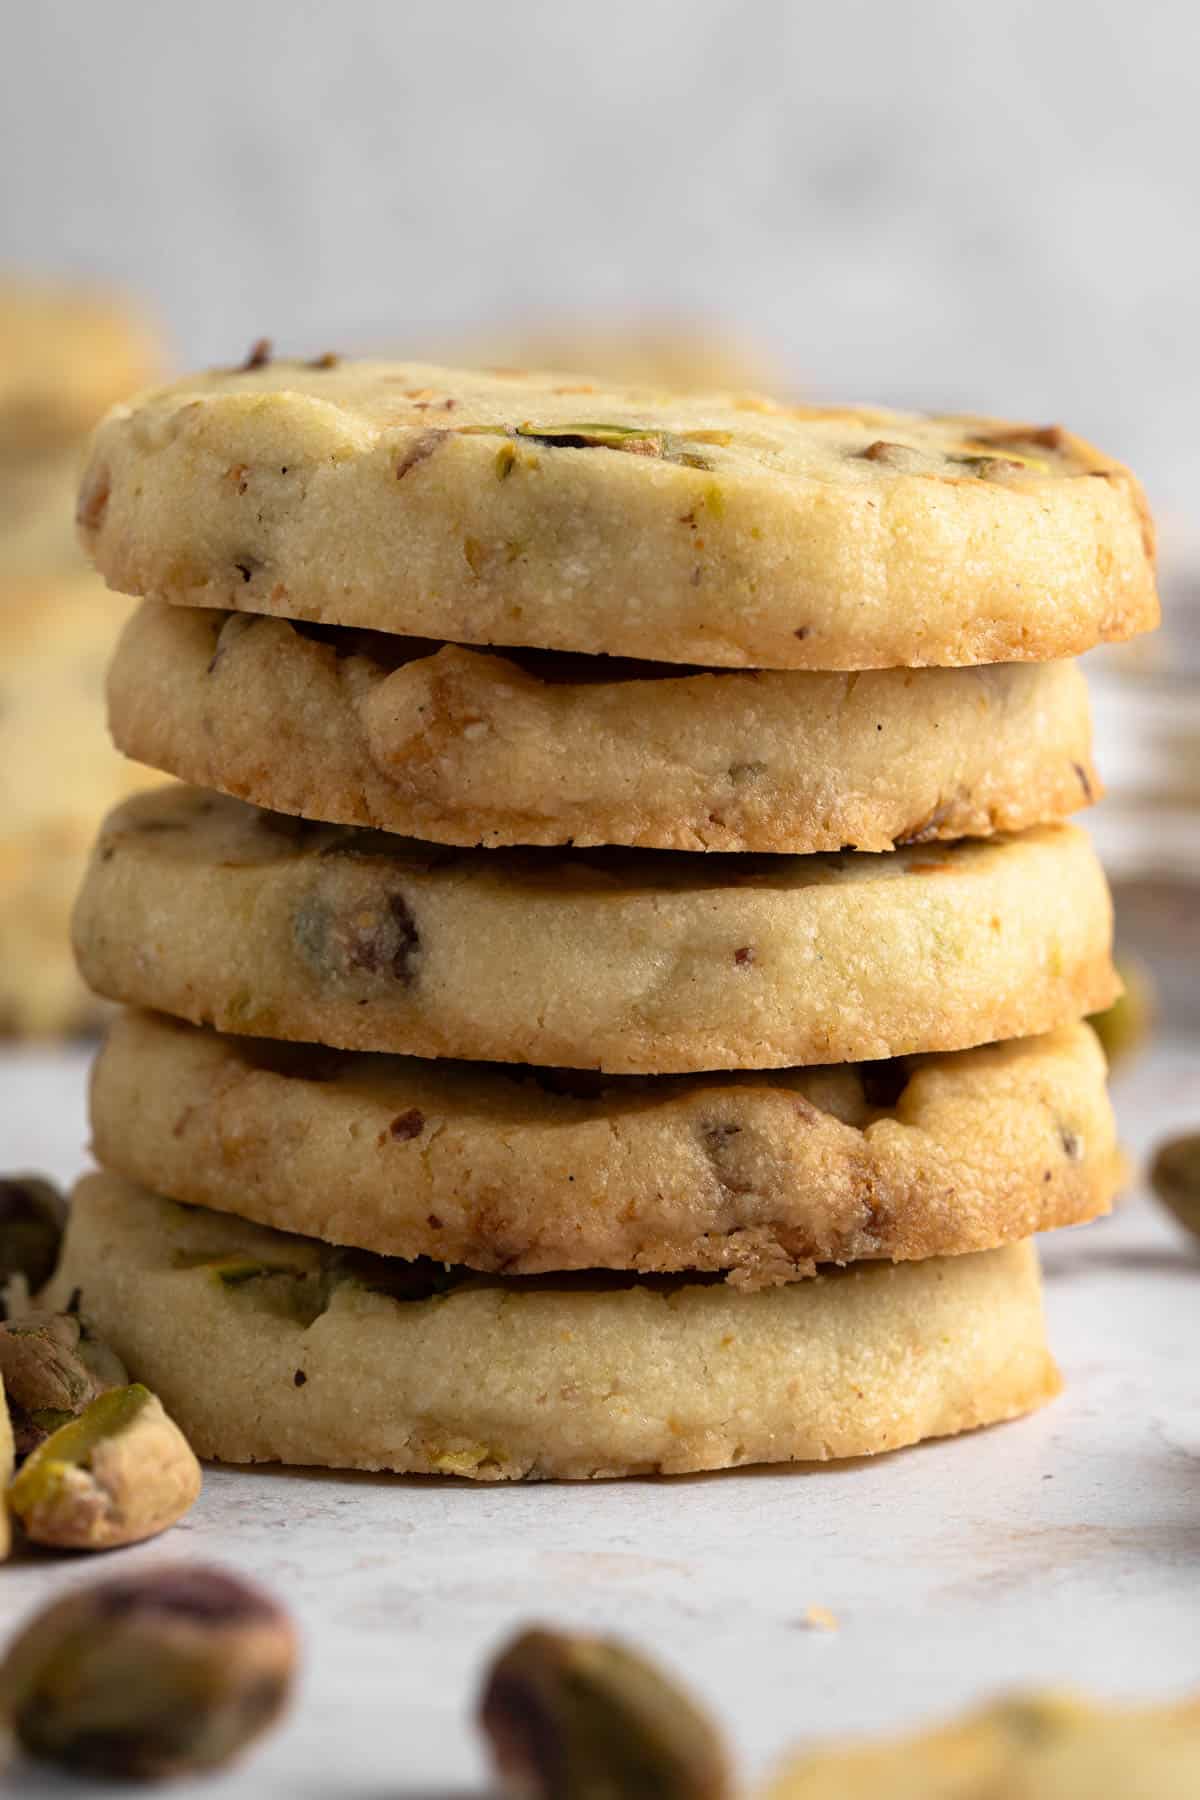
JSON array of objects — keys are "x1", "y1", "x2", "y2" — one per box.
[{"x1": 79, "y1": 356, "x2": 1159, "y2": 670}]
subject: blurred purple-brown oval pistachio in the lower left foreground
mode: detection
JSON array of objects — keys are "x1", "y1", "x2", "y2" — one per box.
[{"x1": 0, "y1": 1566, "x2": 297, "y2": 1780}]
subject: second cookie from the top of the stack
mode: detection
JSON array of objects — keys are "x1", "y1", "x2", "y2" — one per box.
[{"x1": 108, "y1": 601, "x2": 1099, "y2": 851}]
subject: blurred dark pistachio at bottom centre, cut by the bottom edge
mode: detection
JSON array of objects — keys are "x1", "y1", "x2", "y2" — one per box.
[{"x1": 479, "y1": 1629, "x2": 732, "y2": 1800}]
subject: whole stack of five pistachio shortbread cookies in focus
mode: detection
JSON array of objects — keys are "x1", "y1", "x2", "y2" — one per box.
[{"x1": 58, "y1": 351, "x2": 1157, "y2": 1480}]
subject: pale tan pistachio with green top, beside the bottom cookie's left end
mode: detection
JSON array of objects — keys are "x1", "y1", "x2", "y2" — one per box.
[{"x1": 9, "y1": 1382, "x2": 201, "y2": 1550}]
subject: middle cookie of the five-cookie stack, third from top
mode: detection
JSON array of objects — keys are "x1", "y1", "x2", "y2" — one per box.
[{"x1": 74, "y1": 787, "x2": 1115, "y2": 1075}]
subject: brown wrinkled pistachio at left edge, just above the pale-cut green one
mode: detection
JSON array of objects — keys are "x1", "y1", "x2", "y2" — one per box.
[{"x1": 0, "y1": 1312, "x2": 130, "y2": 1456}]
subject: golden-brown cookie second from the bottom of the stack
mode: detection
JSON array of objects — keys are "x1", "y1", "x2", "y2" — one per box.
[{"x1": 92, "y1": 1013, "x2": 1119, "y2": 1287}]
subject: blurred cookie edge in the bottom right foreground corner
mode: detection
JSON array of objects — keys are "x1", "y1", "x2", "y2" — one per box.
[{"x1": 761, "y1": 1694, "x2": 1200, "y2": 1800}]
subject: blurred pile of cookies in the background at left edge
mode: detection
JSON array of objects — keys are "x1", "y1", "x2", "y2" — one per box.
[{"x1": 0, "y1": 275, "x2": 166, "y2": 1037}]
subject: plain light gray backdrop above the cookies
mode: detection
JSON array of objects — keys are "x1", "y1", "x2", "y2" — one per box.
[{"x1": 0, "y1": 0, "x2": 1200, "y2": 511}]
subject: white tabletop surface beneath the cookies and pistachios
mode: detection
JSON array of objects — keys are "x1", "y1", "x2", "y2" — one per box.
[{"x1": 0, "y1": 1039, "x2": 1200, "y2": 1800}]
